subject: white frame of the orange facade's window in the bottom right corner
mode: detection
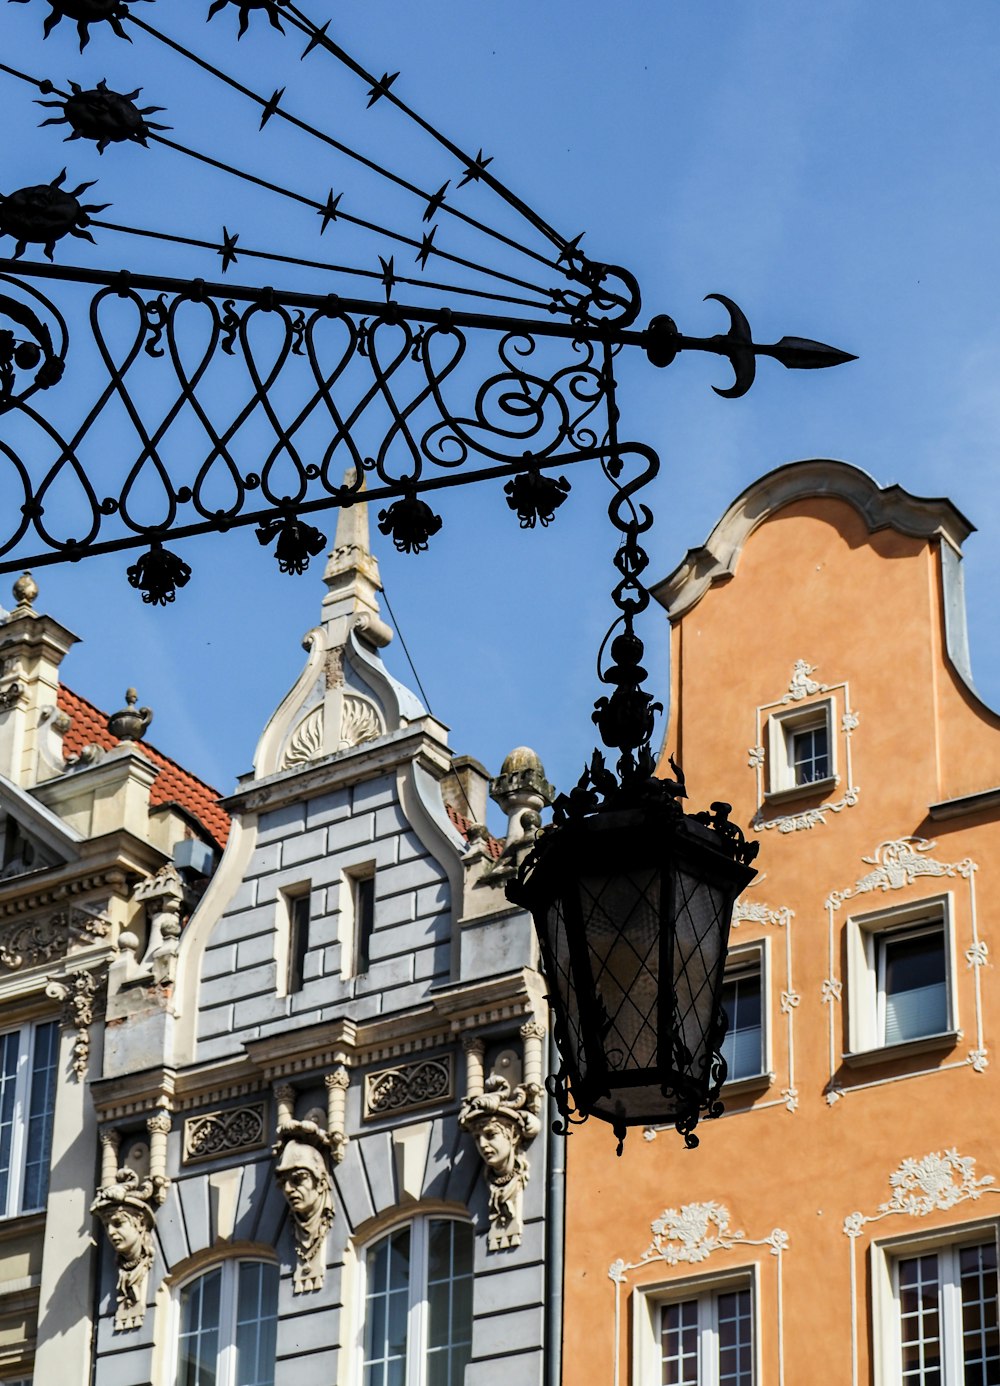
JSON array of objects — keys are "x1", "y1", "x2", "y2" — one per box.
[{"x1": 870, "y1": 1218, "x2": 1000, "y2": 1386}]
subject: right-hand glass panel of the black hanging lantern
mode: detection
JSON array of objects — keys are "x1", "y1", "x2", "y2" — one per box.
[{"x1": 673, "y1": 870, "x2": 733, "y2": 1084}]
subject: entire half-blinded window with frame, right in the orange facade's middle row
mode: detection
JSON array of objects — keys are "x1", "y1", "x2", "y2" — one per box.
[{"x1": 848, "y1": 897, "x2": 957, "y2": 1052}]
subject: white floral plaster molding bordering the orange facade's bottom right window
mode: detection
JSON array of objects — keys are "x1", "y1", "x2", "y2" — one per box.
[{"x1": 843, "y1": 1148, "x2": 1000, "y2": 1386}]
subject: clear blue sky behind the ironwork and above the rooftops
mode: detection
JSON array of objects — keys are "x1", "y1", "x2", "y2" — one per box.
[{"x1": 0, "y1": 0, "x2": 1000, "y2": 831}]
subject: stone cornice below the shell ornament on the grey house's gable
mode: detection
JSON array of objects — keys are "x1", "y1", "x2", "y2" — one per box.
[{"x1": 220, "y1": 722, "x2": 452, "y2": 814}]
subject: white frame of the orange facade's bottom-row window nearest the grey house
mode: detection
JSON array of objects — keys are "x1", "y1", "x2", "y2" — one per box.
[{"x1": 632, "y1": 1263, "x2": 763, "y2": 1386}]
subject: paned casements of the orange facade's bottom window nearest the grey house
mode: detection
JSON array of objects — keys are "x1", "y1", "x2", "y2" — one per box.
[{"x1": 659, "y1": 1286, "x2": 756, "y2": 1386}]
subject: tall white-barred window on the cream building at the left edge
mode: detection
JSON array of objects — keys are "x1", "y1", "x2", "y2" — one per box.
[{"x1": 0, "y1": 1020, "x2": 60, "y2": 1217}]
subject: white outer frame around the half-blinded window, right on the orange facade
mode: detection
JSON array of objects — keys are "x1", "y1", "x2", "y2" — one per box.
[{"x1": 845, "y1": 891, "x2": 958, "y2": 1063}]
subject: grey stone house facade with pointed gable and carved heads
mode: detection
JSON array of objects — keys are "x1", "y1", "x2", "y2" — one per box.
[{"x1": 93, "y1": 506, "x2": 561, "y2": 1386}]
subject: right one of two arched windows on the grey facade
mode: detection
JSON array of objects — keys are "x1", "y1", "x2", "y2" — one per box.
[{"x1": 361, "y1": 1217, "x2": 472, "y2": 1386}]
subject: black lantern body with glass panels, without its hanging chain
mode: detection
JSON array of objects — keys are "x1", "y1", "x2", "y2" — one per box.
[{"x1": 508, "y1": 780, "x2": 758, "y2": 1155}]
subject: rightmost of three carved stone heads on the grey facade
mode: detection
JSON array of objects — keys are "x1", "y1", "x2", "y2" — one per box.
[{"x1": 458, "y1": 1021, "x2": 543, "y2": 1252}]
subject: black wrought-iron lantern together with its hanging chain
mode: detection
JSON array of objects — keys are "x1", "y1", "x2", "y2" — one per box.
[{"x1": 507, "y1": 455, "x2": 759, "y2": 1155}]
